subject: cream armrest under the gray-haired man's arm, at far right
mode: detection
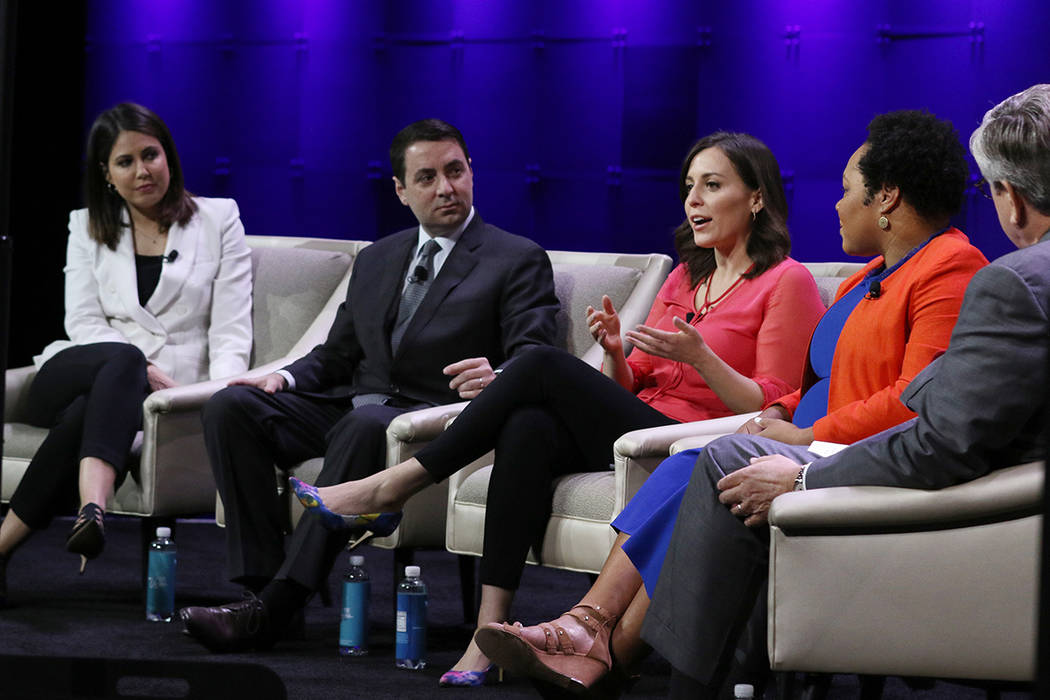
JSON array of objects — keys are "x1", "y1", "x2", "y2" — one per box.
[{"x1": 770, "y1": 462, "x2": 1044, "y2": 536}]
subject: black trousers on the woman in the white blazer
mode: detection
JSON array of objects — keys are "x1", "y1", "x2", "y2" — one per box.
[{"x1": 11, "y1": 342, "x2": 149, "y2": 530}]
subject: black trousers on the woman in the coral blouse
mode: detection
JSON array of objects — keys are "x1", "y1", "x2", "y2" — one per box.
[{"x1": 416, "y1": 347, "x2": 675, "y2": 590}]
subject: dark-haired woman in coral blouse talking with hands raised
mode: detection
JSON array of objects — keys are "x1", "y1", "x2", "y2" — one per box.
[{"x1": 296, "y1": 133, "x2": 823, "y2": 685}]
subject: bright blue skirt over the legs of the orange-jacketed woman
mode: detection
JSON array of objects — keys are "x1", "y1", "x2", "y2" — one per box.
[{"x1": 612, "y1": 447, "x2": 704, "y2": 597}]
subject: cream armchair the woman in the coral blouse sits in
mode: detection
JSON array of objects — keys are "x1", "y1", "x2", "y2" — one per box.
[{"x1": 445, "y1": 262, "x2": 862, "y2": 574}]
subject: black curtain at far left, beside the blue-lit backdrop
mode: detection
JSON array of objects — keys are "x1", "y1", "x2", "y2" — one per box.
[{"x1": 0, "y1": 0, "x2": 89, "y2": 367}]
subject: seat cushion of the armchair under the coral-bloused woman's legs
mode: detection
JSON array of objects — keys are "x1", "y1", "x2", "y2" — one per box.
[{"x1": 456, "y1": 466, "x2": 616, "y2": 523}]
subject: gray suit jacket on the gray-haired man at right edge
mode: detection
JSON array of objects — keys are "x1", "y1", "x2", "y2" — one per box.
[{"x1": 806, "y1": 233, "x2": 1050, "y2": 489}]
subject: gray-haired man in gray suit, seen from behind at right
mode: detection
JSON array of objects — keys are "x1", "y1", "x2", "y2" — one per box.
[{"x1": 643, "y1": 85, "x2": 1050, "y2": 698}]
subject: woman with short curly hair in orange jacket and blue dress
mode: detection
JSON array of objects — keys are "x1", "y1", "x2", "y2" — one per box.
[{"x1": 477, "y1": 111, "x2": 987, "y2": 692}]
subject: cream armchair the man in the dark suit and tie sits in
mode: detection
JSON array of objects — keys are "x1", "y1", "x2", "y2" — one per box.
[{"x1": 270, "y1": 251, "x2": 671, "y2": 617}]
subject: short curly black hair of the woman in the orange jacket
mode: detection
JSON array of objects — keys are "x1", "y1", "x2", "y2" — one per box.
[{"x1": 857, "y1": 110, "x2": 969, "y2": 220}]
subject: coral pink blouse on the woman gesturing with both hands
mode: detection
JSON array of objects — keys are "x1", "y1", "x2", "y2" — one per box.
[{"x1": 627, "y1": 258, "x2": 824, "y2": 422}]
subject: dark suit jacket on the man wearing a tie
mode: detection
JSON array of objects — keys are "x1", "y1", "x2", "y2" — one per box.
[{"x1": 285, "y1": 211, "x2": 559, "y2": 404}]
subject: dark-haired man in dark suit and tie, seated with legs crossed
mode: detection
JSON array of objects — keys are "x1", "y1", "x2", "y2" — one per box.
[{"x1": 182, "y1": 120, "x2": 559, "y2": 651}]
